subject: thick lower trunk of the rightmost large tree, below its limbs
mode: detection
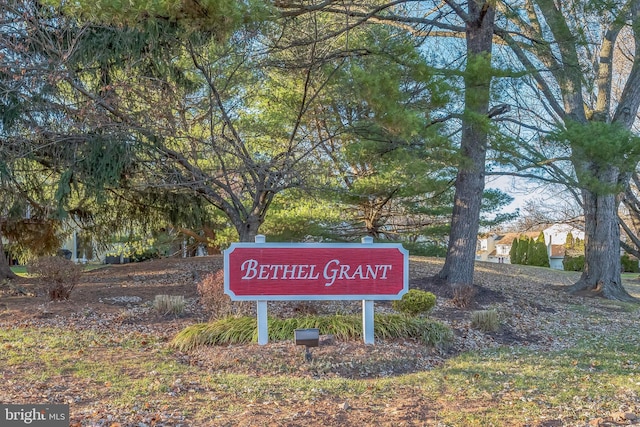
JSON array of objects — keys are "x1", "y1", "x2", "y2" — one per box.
[{"x1": 569, "y1": 166, "x2": 634, "y2": 301}]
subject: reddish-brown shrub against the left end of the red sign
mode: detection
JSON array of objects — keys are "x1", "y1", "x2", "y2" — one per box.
[{"x1": 198, "y1": 270, "x2": 251, "y2": 319}]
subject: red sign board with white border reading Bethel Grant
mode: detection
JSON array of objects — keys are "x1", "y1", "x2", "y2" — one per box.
[{"x1": 224, "y1": 243, "x2": 409, "y2": 301}]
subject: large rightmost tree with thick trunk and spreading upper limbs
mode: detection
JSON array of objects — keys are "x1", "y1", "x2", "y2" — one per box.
[{"x1": 495, "y1": 0, "x2": 640, "y2": 301}]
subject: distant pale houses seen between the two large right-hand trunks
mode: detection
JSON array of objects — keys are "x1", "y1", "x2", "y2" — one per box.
[{"x1": 476, "y1": 224, "x2": 584, "y2": 270}]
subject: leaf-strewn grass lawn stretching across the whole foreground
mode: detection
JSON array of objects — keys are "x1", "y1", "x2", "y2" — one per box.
[{"x1": 5, "y1": 260, "x2": 640, "y2": 427}]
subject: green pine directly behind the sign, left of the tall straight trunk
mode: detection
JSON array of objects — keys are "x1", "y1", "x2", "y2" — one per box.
[{"x1": 302, "y1": 26, "x2": 453, "y2": 239}]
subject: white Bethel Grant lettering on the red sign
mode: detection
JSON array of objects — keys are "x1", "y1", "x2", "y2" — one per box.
[{"x1": 240, "y1": 259, "x2": 391, "y2": 286}]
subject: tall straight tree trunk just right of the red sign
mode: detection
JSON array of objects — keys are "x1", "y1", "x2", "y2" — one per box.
[{"x1": 439, "y1": 0, "x2": 495, "y2": 285}]
